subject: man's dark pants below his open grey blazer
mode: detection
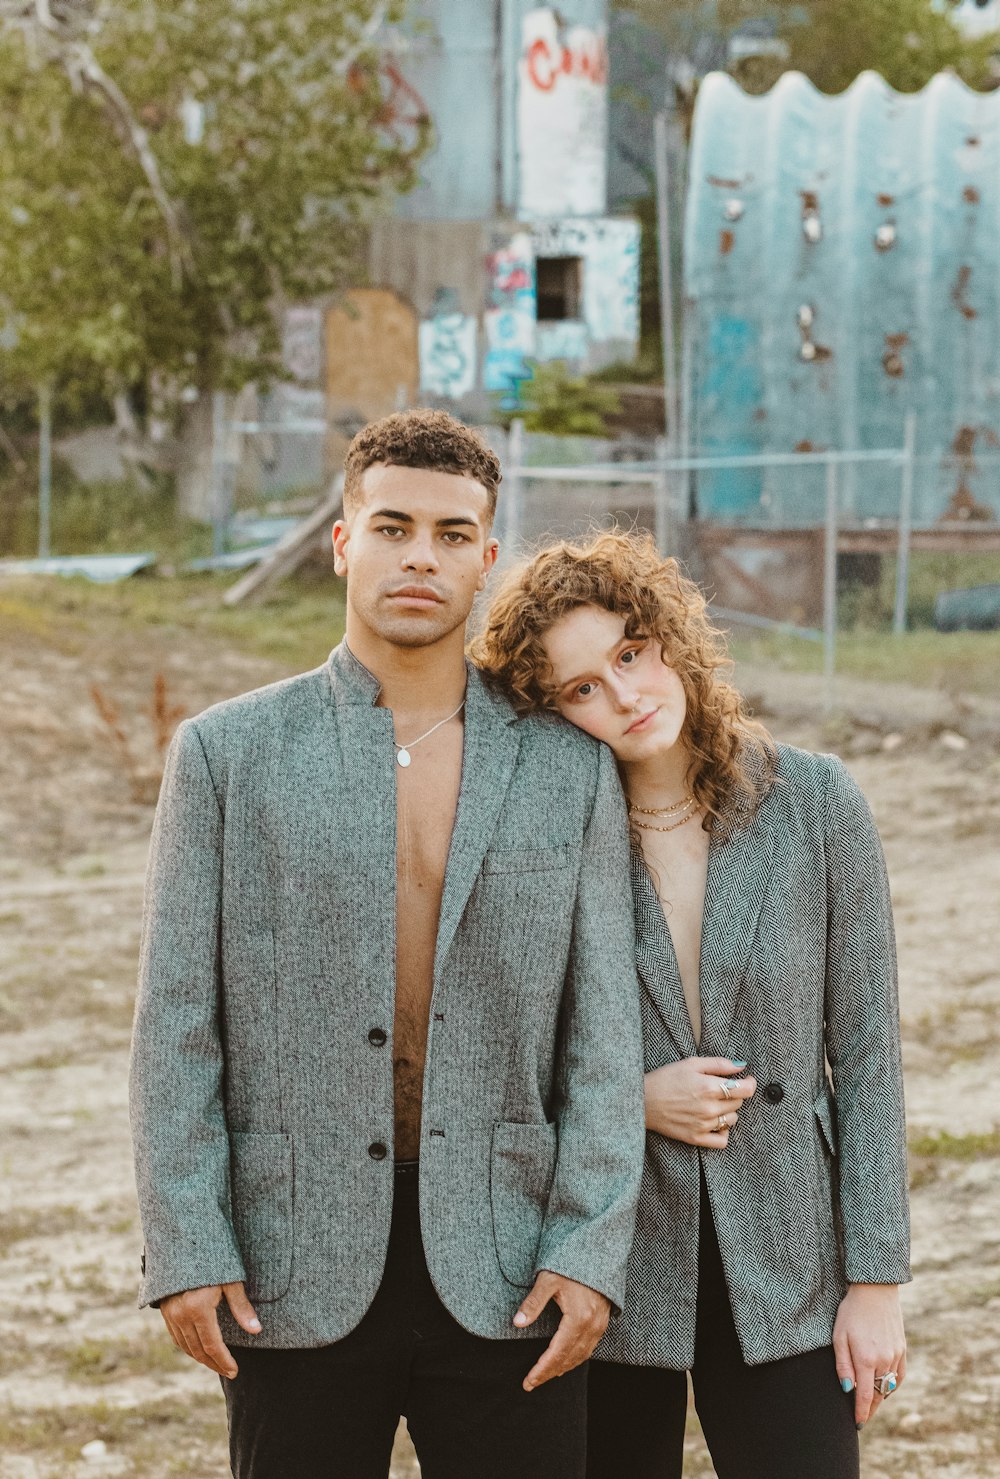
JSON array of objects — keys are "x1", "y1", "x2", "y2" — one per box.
[{"x1": 222, "y1": 1165, "x2": 587, "y2": 1479}]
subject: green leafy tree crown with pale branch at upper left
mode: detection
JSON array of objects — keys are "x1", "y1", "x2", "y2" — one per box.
[{"x1": 0, "y1": 0, "x2": 429, "y2": 508}]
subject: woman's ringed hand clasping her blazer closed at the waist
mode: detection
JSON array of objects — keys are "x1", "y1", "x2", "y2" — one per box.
[{"x1": 645, "y1": 1057, "x2": 757, "y2": 1151}]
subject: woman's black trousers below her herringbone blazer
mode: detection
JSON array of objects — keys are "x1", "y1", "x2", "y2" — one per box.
[{"x1": 587, "y1": 1179, "x2": 858, "y2": 1479}]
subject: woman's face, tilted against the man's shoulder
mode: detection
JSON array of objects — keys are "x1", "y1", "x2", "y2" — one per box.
[{"x1": 541, "y1": 606, "x2": 688, "y2": 765}]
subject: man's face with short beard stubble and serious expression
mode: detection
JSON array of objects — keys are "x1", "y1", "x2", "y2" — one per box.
[{"x1": 333, "y1": 463, "x2": 499, "y2": 648}]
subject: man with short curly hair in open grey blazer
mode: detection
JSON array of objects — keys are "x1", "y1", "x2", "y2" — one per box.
[{"x1": 132, "y1": 411, "x2": 643, "y2": 1479}]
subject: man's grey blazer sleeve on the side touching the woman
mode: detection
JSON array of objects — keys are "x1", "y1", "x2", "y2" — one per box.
[{"x1": 537, "y1": 745, "x2": 645, "y2": 1309}]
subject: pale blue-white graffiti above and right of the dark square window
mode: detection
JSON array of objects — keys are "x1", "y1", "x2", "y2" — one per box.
[{"x1": 533, "y1": 220, "x2": 639, "y2": 346}]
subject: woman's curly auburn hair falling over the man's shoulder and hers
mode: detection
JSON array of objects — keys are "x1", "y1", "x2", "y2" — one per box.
[{"x1": 470, "y1": 529, "x2": 777, "y2": 834}]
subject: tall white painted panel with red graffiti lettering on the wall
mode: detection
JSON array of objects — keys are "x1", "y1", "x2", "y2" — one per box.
[{"x1": 518, "y1": 7, "x2": 608, "y2": 220}]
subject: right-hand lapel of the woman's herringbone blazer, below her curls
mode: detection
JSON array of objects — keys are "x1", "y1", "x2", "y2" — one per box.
[{"x1": 701, "y1": 796, "x2": 774, "y2": 1056}]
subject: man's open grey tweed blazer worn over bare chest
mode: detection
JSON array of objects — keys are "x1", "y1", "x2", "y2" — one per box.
[{"x1": 130, "y1": 645, "x2": 643, "y2": 1347}]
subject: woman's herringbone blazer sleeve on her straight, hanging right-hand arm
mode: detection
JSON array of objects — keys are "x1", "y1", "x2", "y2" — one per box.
[{"x1": 825, "y1": 757, "x2": 910, "y2": 1284}]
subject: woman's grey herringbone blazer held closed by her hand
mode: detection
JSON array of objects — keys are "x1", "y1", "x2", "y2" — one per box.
[{"x1": 598, "y1": 745, "x2": 910, "y2": 1366}]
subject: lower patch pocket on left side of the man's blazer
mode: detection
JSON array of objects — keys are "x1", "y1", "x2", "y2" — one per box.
[{"x1": 229, "y1": 1131, "x2": 293, "y2": 1304}]
